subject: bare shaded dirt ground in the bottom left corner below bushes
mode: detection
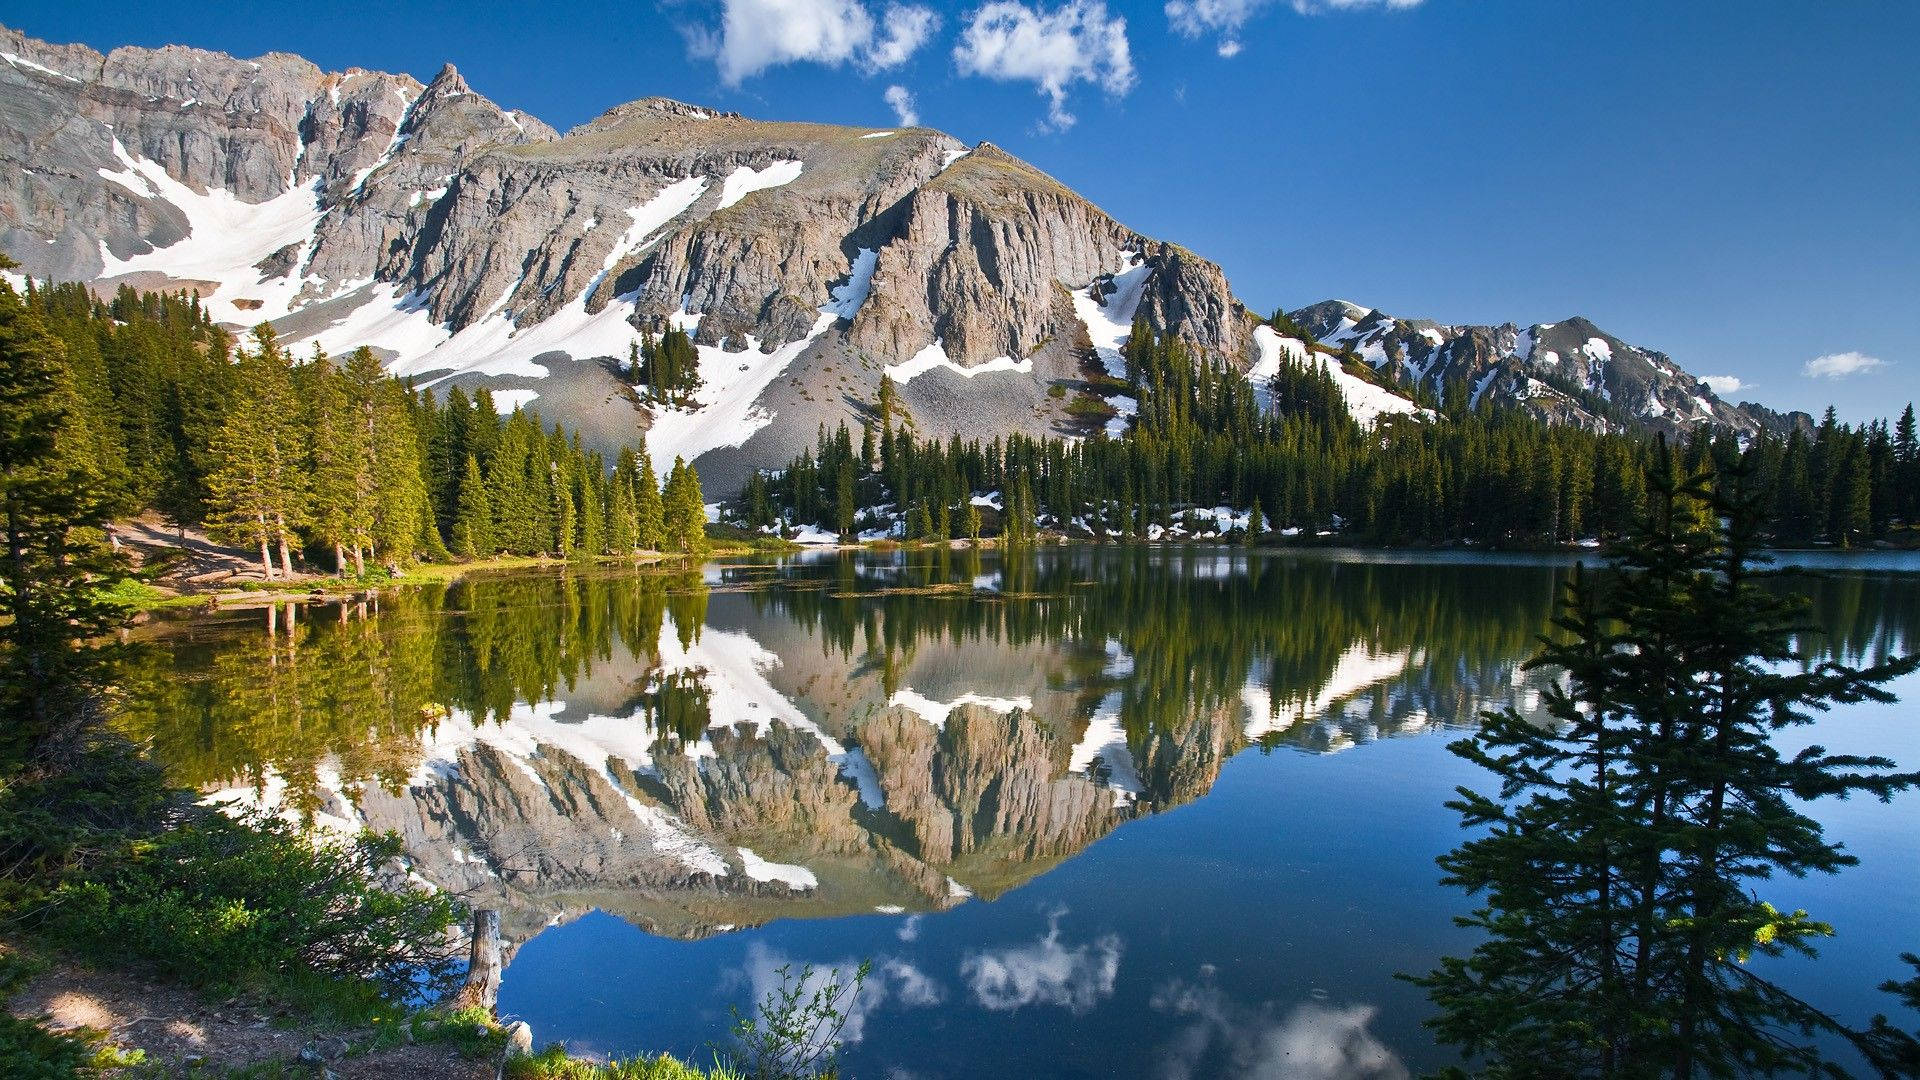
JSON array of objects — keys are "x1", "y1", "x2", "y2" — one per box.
[{"x1": 8, "y1": 949, "x2": 497, "y2": 1080}]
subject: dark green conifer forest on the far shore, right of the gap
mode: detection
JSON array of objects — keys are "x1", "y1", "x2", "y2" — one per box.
[{"x1": 741, "y1": 313, "x2": 1920, "y2": 546}]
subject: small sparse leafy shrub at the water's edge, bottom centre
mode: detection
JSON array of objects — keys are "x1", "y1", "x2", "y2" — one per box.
[{"x1": 728, "y1": 963, "x2": 872, "y2": 1080}]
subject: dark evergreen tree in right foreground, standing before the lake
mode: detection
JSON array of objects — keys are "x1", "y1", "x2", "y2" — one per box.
[{"x1": 1415, "y1": 444, "x2": 1920, "y2": 1078}]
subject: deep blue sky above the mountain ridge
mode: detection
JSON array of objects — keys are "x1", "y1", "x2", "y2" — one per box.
[{"x1": 18, "y1": 0, "x2": 1920, "y2": 419}]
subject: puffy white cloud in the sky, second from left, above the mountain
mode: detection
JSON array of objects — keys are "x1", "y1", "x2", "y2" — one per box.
[{"x1": 954, "y1": 0, "x2": 1135, "y2": 131}]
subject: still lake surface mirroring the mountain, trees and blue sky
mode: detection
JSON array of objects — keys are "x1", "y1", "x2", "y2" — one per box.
[{"x1": 116, "y1": 550, "x2": 1920, "y2": 1076}]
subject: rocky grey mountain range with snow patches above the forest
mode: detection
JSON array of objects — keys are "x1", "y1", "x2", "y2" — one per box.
[{"x1": 0, "y1": 29, "x2": 1778, "y2": 494}]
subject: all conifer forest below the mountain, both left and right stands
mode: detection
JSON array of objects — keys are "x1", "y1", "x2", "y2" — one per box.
[{"x1": 7, "y1": 274, "x2": 1920, "y2": 577}]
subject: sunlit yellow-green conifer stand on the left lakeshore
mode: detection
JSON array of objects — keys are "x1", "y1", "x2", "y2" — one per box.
[{"x1": 23, "y1": 284, "x2": 707, "y2": 578}]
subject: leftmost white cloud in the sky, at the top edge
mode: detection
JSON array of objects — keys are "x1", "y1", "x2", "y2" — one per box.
[{"x1": 685, "y1": 0, "x2": 939, "y2": 86}]
